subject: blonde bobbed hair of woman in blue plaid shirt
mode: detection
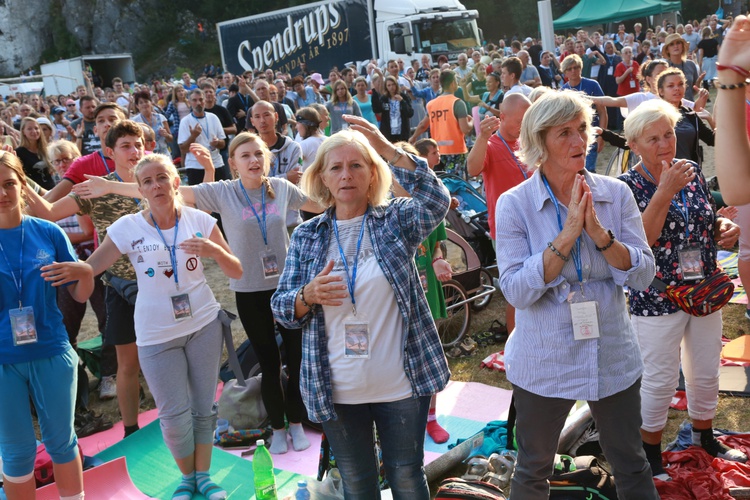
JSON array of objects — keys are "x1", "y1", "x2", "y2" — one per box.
[{"x1": 300, "y1": 130, "x2": 393, "y2": 207}]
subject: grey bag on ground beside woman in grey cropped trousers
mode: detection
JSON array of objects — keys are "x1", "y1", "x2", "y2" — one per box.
[{"x1": 219, "y1": 375, "x2": 268, "y2": 429}]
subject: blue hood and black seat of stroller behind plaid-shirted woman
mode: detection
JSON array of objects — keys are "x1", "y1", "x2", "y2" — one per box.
[{"x1": 437, "y1": 172, "x2": 495, "y2": 267}]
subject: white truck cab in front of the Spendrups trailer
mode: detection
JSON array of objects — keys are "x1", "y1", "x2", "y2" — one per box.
[{"x1": 373, "y1": 0, "x2": 482, "y2": 62}]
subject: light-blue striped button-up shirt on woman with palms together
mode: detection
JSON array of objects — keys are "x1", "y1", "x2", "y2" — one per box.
[{"x1": 495, "y1": 172, "x2": 654, "y2": 401}]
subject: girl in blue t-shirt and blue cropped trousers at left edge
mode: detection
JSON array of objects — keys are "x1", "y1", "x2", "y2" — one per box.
[{"x1": 0, "y1": 150, "x2": 93, "y2": 500}]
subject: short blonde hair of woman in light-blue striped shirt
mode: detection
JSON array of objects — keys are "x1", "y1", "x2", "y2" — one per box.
[{"x1": 518, "y1": 89, "x2": 594, "y2": 167}]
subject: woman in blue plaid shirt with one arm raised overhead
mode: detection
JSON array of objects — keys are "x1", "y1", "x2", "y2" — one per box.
[{"x1": 272, "y1": 115, "x2": 450, "y2": 500}]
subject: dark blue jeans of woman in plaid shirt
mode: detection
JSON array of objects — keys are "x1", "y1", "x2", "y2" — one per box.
[{"x1": 323, "y1": 396, "x2": 430, "y2": 500}]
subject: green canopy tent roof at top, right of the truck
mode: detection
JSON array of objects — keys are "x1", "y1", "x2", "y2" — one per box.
[{"x1": 553, "y1": 0, "x2": 682, "y2": 30}]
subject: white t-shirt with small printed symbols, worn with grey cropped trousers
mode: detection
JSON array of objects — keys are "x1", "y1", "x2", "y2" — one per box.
[{"x1": 107, "y1": 207, "x2": 220, "y2": 346}]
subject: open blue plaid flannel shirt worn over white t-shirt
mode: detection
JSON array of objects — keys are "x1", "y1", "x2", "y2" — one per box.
[{"x1": 271, "y1": 156, "x2": 450, "y2": 422}]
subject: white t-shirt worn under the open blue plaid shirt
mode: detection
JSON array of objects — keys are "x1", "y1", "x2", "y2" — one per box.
[{"x1": 323, "y1": 216, "x2": 412, "y2": 404}]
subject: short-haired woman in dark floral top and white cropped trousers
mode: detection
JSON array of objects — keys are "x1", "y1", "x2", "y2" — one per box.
[{"x1": 620, "y1": 98, "x2": 747, "y2": 480}]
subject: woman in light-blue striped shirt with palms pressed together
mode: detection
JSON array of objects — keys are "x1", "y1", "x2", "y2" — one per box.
[{"x1": 495, "y1": 91, "x2": 658, "y2": 500}]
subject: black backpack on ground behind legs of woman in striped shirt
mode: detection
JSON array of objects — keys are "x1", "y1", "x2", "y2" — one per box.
[{"x1": 549, "y1": 455, "x2": 617, "y2": 500}]
